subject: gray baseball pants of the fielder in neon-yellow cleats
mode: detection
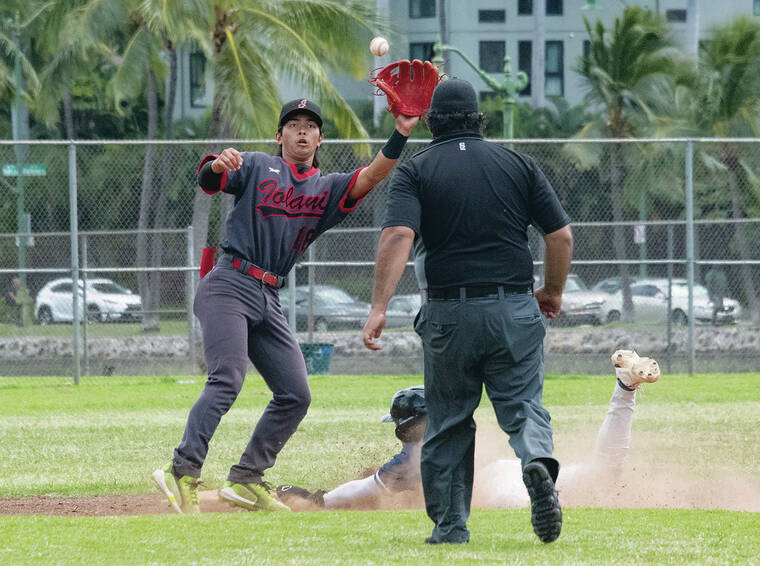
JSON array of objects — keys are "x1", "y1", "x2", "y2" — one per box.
[{"x1": 174, "y1": 255, "x2": 311, "y2": 483}]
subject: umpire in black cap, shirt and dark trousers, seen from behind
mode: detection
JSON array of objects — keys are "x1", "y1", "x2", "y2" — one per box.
[{"x1": 364, "y1": 78, "x2": 573, "y2": 544}]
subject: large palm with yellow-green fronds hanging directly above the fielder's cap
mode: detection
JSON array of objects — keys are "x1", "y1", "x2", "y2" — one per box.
[{"x1": 179, "y1": 0, "x2": 380, "y2": 262}]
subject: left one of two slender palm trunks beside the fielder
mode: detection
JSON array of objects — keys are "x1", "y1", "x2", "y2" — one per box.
[{"x1": 137, "y1": 70, "x2": 158, "y2": 332}]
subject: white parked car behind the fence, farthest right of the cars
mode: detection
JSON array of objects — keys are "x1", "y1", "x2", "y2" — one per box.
[{"x1": 603, "y1": 277, "x2": 742, "y2": 325}]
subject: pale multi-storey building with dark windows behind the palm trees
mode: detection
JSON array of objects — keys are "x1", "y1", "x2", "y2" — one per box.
[{"x1": 175, "y1": 0, "x2": 760, "y2": 124}]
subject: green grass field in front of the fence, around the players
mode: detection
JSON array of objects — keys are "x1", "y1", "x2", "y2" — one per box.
[{"x1": 0, "y1": 374, "x2": 760, "y2": 565}]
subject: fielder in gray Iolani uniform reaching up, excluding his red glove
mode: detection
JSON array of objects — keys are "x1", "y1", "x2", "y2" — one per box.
[{"x1": 152, "y1": 99, "x2": 419, "y2": 513}]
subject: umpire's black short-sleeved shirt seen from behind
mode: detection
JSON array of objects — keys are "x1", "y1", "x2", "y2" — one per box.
[{"x1": 383, "y1": 131, "x2": 570, "y2": 289}]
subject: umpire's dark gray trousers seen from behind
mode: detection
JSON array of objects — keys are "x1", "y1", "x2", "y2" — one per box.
[{"x1": 415, "y1": 288, "x2": 559, "y2": 542}]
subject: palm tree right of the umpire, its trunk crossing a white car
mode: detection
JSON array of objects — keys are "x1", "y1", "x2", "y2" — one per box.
[{"x1": 576, "y1": 6, "x2": 678, "y2": 321}]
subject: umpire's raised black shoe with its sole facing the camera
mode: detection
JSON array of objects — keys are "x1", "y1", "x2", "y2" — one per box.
[{"x1": 523, "y1": 460, "x2": 562, "y2": 542}]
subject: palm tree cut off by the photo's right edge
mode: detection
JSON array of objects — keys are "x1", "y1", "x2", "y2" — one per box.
[{"x1": 692, "y1": 17, "x2": 760, "y2": 322}]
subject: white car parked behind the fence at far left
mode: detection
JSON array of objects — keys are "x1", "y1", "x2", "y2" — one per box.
[{"x1": 34, "y1": 277, "x2": 142, "y2": 324}]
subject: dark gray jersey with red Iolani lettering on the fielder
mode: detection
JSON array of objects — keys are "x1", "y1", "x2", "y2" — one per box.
[{"x1": 199, "y1": 151, "x2": 361, "y2": 276}]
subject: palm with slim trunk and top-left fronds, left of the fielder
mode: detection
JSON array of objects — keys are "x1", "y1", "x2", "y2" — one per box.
[{"x1": 67, "y1": 0, "x2": 206, "y2": 331}]
